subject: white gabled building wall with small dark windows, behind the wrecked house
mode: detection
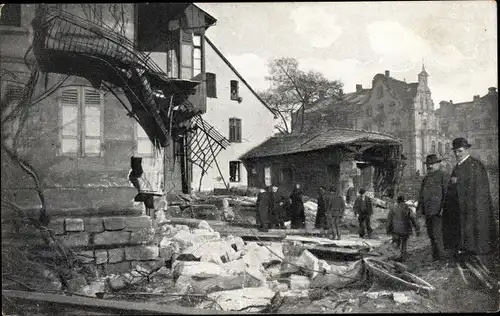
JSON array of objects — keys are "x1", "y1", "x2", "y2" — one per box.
[{"x1": 192, "y1": 37, "x2": 275, "y2": 191}]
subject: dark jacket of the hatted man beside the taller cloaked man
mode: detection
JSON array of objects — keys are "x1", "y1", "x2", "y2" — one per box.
[{"x1": 417, "y1": 170, "x2": 450, "y2": 218}]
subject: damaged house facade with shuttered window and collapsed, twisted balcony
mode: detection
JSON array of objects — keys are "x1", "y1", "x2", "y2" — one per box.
[{"x1": 0, "y1": 3, "x2": 228, "y2": 214}]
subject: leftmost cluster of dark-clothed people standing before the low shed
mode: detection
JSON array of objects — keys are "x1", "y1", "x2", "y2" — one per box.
[{"x1": 256, "y1": 184, "x2": 306, "y2": 232}]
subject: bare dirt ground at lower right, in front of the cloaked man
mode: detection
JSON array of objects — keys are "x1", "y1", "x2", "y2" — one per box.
[{"x1": 279, "y1": 221, "x2": 498, "y2": 314}]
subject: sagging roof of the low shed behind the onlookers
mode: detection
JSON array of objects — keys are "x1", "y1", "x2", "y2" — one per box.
[{"x1": 240, "y1": 128, "x2": 400, "y2": 160}]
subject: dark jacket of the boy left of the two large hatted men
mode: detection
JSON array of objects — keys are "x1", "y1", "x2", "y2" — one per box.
[{"x1": 387, "y1": 203, "x2": 420, "y2": 236}]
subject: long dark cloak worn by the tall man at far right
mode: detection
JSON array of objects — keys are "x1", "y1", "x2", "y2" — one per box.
[{"x1": 443, "y1": 157, "x2": 498, "y2": 254}]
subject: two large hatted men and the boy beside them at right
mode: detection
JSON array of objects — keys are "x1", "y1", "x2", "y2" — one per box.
[{"x1": 387, "y1": 138, "x2": 498, "y2": 261}]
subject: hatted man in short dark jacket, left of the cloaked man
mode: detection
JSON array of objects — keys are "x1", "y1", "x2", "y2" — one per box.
[{"x1": 417, "y1": 154, "x2": 449, "y2": 261}]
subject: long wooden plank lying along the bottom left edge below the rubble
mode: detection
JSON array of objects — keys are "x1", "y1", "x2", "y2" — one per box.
[{"x1": 2, "y1": 290, "x2": 235, "y2": 315}]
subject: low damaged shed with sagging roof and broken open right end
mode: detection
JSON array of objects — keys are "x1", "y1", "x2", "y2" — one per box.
[{"x1": 240, "y1": 128, "x2": 405, "y2": 196}]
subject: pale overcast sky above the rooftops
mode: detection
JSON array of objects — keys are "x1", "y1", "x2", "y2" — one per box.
[{"x1": 196, "y1": 0, "x2": 498, "y2": 108}]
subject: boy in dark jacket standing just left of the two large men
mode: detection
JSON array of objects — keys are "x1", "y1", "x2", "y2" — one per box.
[{"x1": 387, "y1": 196, "x2": 420, "y2": 262}]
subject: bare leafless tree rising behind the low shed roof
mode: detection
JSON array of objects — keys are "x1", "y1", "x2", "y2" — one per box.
[{"x1": 259, "y1": 57, "x2": 342, "y2": 134}]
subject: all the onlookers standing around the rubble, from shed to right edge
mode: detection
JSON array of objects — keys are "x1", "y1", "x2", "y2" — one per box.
[{"x1": 257, "y1": 138, "x2": 498, "y2": 268}]
